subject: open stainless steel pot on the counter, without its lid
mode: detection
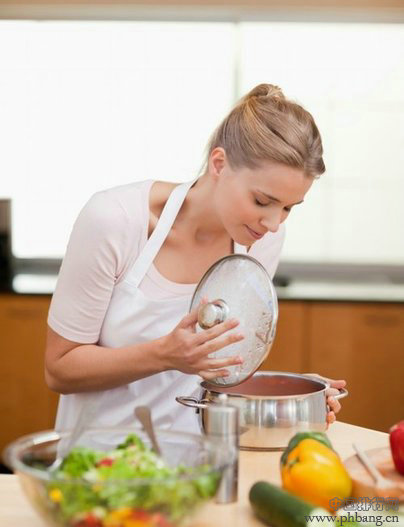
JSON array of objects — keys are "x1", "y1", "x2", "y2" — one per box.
[{"x1": 176, "y1": 372, "x2": 348, "y2": 451}]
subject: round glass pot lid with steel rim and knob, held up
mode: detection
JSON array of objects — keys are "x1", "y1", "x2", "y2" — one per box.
[{"x1": 190, "y1": 254, "x2": 278, "y2": 386}]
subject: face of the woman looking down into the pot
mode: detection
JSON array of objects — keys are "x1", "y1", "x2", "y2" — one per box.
[{"x1": 210, "y1": 148, "x2": 313, "y2": 246}]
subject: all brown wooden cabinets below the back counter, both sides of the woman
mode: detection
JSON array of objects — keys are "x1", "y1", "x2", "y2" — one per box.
[{"x1": 0, "y1": 294, "x2": 404, "y2": 458}]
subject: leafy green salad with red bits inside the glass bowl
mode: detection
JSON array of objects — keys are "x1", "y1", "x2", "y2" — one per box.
[{"x1": 46, "y1": 434, "x2": 220, "y2": 527}]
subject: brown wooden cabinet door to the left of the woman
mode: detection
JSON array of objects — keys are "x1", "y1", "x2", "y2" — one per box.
[{"x1": 0, "y1": 295, "x2": 58, "y2": 456}]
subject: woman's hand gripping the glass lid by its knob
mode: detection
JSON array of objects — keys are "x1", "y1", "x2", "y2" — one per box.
[{"x1": 160, "y1": 306, "x2": 244, "y2": 381}]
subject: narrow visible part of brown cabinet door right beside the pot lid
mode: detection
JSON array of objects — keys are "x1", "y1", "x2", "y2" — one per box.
[{"x1": 260, "y1": 301, "x2": 308, "y2": 373}]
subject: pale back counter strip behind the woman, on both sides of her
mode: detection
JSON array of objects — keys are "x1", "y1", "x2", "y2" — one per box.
[{"x1": 0, "y1": 259, "x2": 404, "y2": 303}]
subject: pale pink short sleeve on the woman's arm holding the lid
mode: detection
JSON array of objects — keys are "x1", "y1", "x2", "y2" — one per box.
[{"x1": 48, "y1": 191, "x2": 137, "y2": 344}]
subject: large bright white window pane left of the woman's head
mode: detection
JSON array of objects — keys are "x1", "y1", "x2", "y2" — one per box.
[{"x1": 0, "y1": 21, "x2": 235, "y2": 258}]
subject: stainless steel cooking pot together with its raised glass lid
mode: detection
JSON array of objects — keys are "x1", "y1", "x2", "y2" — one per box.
[{"x1": 176, "y1": 254, "x2": 348, "y2": 450}]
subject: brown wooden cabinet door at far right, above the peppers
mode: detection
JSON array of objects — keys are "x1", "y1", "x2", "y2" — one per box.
[{"x1": 308, "y1": 302, "x2": 404, "y2": 432}]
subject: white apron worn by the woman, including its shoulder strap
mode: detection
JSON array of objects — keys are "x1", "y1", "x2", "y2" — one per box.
[{"x1": 55, "y1": 180, "x2": 246, "y2": 433}]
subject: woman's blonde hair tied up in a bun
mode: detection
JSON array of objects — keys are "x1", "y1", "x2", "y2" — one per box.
[{"x1": 205, "y1": 84, "x2": 325, "y2": 178}]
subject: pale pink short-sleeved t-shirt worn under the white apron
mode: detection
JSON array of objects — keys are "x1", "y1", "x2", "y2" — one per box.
[{"x1": 48, "y1": 180, "x2": 285, "y2": 344}]
